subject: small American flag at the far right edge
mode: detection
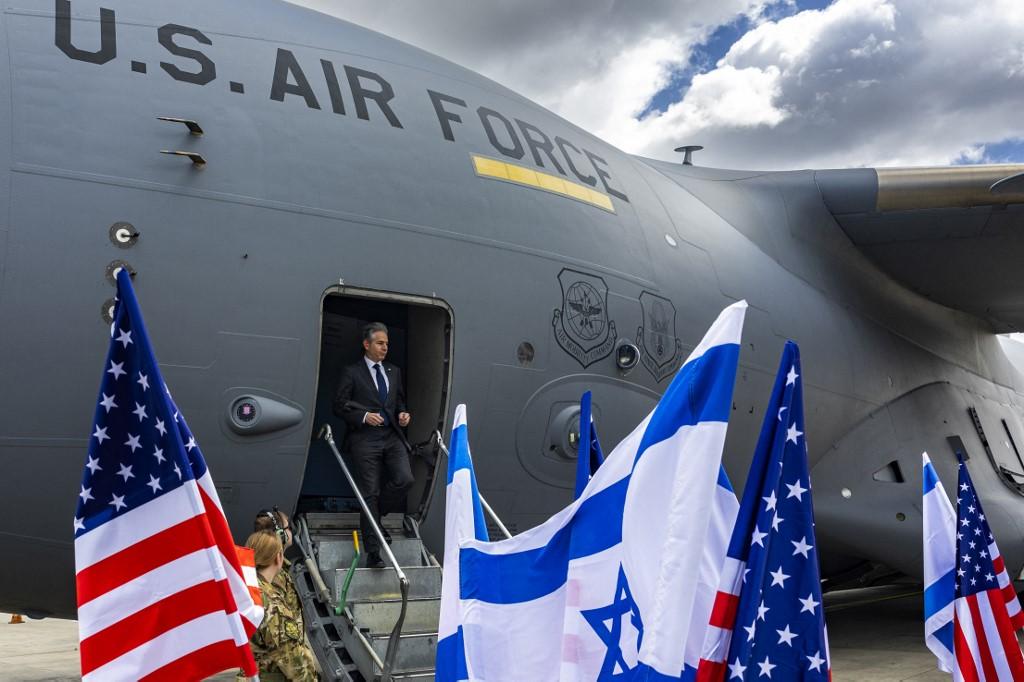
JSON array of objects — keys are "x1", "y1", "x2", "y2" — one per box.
[{"x1": 953, "y1": 454, "x2": 1024, "y2": 682}]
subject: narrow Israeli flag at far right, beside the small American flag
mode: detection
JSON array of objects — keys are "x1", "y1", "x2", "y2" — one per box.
[{"x1": 921, "y1": 453, "x2": 956, "y2": 673}]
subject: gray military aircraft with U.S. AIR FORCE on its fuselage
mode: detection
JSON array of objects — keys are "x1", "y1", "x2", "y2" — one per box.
[{"x1": 0, "y1": 0, "x2": 1024, "y2": 616}]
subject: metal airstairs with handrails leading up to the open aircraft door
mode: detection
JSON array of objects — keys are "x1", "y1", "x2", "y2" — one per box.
[{"x1": 292, "y1": 427, "x2": 510, "y2": 682}]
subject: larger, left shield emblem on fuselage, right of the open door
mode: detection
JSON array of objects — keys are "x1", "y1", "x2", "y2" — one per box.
[{"x1": 551, "y1": 268, "x2": 616, "y2": 368}]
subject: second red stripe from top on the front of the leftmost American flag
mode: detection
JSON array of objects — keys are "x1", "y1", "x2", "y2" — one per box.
[{"x1": 81, "y1": 581, "x2": 233, "y2": 676}]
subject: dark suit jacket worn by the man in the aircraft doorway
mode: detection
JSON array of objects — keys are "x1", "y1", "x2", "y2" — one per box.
[{"x1": 333, "y1": 357, "x2": 406, "y2": 442}]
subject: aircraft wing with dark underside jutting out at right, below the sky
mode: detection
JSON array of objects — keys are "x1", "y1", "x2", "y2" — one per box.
[{"x1": 815, "y1": 165, "x2": 1024, "y2": 333}]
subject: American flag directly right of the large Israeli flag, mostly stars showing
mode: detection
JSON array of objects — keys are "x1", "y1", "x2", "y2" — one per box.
[{"x1": 697, "y1": 341, "x2": 831, "y2": 682}]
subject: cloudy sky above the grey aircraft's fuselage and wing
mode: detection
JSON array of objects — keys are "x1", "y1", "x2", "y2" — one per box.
[{"x1": 295, "y1": 0, "x2": 1024, "y2": 169}]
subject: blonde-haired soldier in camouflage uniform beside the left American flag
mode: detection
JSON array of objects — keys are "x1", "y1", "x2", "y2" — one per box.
[{"x1": 240, "y1": 532, "x2": 319, "y2": 682}]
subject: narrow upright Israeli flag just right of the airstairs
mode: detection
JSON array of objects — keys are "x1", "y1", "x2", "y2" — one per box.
[{"x1": 436, "y1": 404, "x2": 487, "y2": 680}]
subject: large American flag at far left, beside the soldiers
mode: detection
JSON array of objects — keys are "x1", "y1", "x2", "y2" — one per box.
[{"x1": 75, "y1": 269, "x2": 263, "y2": 680}]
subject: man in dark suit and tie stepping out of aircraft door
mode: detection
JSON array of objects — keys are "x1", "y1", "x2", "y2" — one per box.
[{"x1": 334, "y1": 323, "x2": 413, "y2": 568}]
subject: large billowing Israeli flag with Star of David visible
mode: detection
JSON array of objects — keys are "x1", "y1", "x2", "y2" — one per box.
[{"x1": 436, "y1": 301, "x2": 746, "y2": 682}]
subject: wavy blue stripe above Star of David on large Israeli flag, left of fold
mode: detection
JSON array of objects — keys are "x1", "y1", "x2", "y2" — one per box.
[{"x1": 459, "y1": 476, "x2": 630, "y2": 604}]
